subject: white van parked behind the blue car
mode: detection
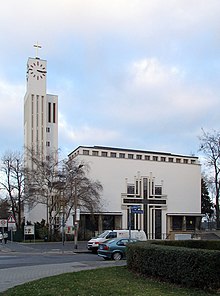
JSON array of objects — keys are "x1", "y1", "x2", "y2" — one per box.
[{"x1": 87, "y1": 229, "x2": 147, "y2": 253}]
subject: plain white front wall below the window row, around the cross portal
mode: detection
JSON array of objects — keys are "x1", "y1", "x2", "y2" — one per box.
[{"x1": 73, "y1": 155, "x2": 201, "y2": 213}]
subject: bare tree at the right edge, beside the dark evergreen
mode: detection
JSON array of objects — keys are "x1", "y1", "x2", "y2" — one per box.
[{"x1": 200, "y1": 130, "x2": 220, "y2": 229}]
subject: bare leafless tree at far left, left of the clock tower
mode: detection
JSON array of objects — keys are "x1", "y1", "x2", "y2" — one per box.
[{"x1": 0, "y1": 152, "x2": 24, "y2": 229}]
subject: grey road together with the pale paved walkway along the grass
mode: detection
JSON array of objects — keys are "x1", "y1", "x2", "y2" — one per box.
[{"x1": 0, "y1": 242, "x2": 126, "y2": 292}]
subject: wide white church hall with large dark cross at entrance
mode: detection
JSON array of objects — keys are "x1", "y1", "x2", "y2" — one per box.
[{"x1": 69, "y1": 146, "x2": 201, "y2": 239}]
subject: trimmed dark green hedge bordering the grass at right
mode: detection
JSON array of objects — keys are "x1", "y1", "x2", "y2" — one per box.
[{"x1": 127, "y1": 241, "x2": 220, "y2": 289}]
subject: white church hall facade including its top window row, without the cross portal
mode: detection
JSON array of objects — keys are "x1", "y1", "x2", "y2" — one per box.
[{"x1": 69, "y1": 147, "x2": 201, "y2": 238}]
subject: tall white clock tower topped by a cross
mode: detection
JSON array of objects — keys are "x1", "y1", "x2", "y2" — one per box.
[{"x1": 24, "y1": 44, "x2": 58, "y2": 222}]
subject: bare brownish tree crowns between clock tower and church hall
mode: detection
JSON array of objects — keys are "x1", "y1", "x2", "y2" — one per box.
[{"x1": 25, "y1": 150, "x2": 102, "y2": 237}]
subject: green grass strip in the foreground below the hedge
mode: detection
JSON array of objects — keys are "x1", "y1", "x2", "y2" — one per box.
[{"x1": 0, "y1": 266, "x2": 219, "y2": 296}]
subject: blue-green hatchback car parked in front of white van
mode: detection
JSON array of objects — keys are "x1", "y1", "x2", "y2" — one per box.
[{"x1": 98, "y1": 238, "x2": 139, "y2": 260}]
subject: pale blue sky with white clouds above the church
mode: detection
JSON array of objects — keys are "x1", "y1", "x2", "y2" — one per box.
[{"x1": 0, "y1": 0, "x2": 220, "y2": 160}]
